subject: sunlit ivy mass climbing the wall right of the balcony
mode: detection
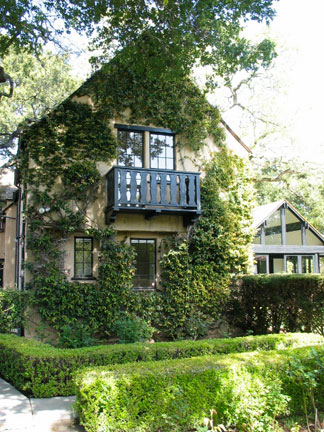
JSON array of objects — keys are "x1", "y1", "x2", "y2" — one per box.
[{"x1": 161, "y1": 151, "x2": 253, "y2": 338}]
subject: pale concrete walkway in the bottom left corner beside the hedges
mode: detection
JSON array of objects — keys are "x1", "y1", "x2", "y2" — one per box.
[{"x1": 0, "y1": 378, "x2": 84, "y2": 432}]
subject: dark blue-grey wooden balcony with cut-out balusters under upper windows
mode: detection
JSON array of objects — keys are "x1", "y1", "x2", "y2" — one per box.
[{"x1": 106, "y1": 166, "x2": 201, "y2": 225}]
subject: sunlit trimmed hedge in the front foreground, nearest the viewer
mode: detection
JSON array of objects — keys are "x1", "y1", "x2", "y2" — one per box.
[{"x1": 76, "y1": 347, "x2": 324, "y2": 432}]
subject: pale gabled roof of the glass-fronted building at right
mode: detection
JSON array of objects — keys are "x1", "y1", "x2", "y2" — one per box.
[{"x1": 252, "y1": 199, "x2": 324, "y2": 242}]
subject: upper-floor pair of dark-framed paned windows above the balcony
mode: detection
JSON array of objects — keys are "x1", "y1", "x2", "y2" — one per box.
[{"x1": 115, "y1": 125, "x2": 175, "y2": 170}]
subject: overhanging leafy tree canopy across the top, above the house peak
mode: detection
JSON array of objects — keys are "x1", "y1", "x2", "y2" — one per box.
[{"x1": 0, "y1": 0, "x2": 275, "y2": 82}]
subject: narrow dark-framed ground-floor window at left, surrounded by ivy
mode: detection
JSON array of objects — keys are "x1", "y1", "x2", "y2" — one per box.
[{"x1": 74, "y1": 237, "x2": 93, "y2": 279}]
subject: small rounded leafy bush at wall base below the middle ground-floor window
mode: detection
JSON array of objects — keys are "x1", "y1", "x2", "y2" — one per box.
[{"x1": 115, "y1": 314, "x2": 155, "y2": 343}]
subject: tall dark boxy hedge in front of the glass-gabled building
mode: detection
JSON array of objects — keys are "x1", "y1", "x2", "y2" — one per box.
[{"x1": 230, "y1": 274, "x2": 324, "y2": 334}]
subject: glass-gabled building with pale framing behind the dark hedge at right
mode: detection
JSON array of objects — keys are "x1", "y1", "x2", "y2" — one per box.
[{"x1": 253, "y1": 200, "x2": 324, "y2": 273}]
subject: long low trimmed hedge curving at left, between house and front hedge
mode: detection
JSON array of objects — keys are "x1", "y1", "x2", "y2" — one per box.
[{"x1": 0, "y1": 333, "x2": 324, "y2": 397}]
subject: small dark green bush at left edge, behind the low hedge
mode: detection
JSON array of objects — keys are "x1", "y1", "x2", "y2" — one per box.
[{"x1": 0, "y1": 289, "x2": 29, "y2": 333}]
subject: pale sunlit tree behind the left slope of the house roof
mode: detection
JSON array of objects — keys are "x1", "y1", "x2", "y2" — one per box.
[{"x1": 0, "y1": 50, "x2": 80, "y2": 156}]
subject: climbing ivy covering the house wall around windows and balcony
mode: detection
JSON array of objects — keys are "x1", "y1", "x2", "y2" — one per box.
[{"x1": 19, "y1": 44, "x2": 250, "y2": 337}]
